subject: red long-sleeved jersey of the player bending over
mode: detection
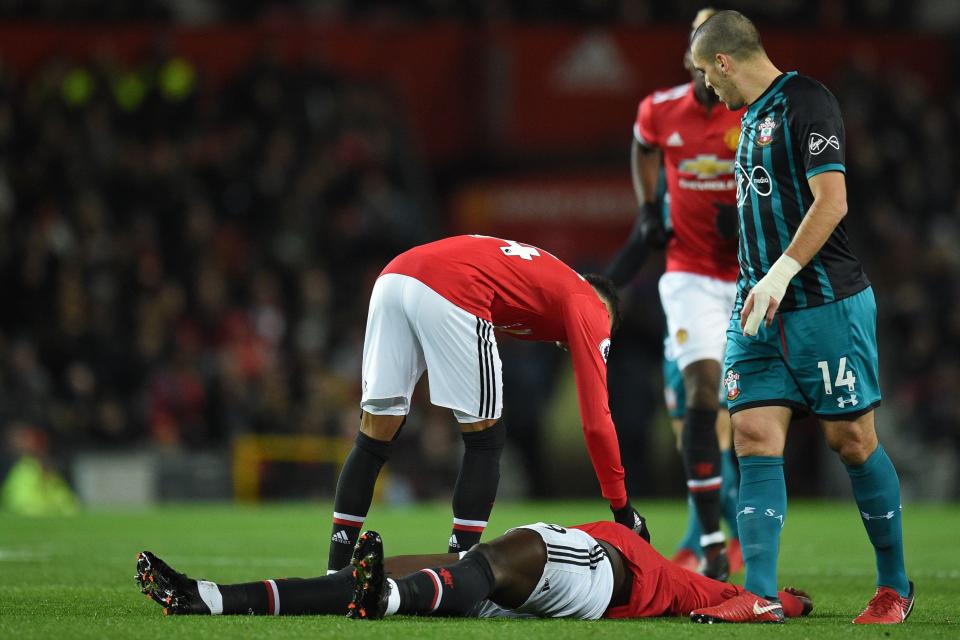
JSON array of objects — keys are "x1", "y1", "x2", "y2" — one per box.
[{"x1": 383, "y1": 236, "x2": 627, "y2": 507}]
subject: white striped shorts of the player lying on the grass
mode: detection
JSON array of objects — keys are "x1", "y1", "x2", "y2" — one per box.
[{"x1": 477, "y1": 522, "x2": 613, "y2": 620}]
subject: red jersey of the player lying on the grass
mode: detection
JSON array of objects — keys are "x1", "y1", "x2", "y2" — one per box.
[{"x1": 570, "y1": 522, "x2": 743, "y2": 618}]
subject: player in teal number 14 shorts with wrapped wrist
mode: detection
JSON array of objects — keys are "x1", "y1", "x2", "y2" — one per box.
[{"x1": 691, "y1": 11, "x2": 914, "y2": 624}]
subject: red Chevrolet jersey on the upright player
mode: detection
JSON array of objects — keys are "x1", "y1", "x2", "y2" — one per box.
[{"x1": 633, "y1": 82, "x2": 743, "y2": 281}]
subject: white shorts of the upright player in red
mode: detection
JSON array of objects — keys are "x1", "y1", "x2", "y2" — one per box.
[{"x1": 660, "y1": 271, "x2": 737, "y2": 371}]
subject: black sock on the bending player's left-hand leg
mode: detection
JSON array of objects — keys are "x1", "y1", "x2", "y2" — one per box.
[{"x1": 327, "y1": 433, "x2": 393, "y2": 573}]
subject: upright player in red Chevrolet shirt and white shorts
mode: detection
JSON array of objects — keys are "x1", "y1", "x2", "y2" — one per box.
[{"x1": 608, "y1": 9, "x2": 740, "y2": 580}]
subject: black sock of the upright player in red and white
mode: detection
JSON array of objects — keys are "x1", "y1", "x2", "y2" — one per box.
[{"x1": 681, "y1": 408, "x2": 724, "y2": 546}]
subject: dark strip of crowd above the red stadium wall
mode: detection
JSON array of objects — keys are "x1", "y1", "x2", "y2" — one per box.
[{"x1": 0, "y1": 0, "x2": 960, "y2": 30}]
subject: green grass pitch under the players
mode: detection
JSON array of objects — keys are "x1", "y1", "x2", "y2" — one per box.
[{"x1": 0, "y1": 501, "x2": 960, "y2": 640}]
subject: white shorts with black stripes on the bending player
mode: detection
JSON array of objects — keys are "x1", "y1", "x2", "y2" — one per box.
[{"x1": 360, "y1": 273, "x2": 503, "y2": 423}]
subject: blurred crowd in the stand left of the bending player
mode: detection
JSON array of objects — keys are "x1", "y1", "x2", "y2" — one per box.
[{"x1": 0, "y1": 50, "x2": 427, "y2": 476}]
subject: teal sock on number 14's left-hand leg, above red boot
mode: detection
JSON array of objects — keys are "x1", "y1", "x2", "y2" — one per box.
[{"x1": 737, "y1": 456, "x2": 787, "y2": 598}]
